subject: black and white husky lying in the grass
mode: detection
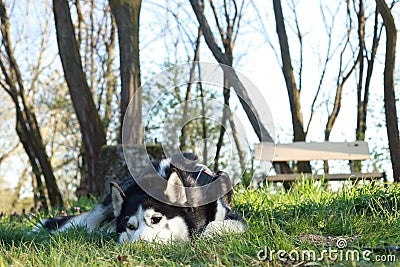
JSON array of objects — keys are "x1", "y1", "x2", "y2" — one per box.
[{"x1": 35, "y1": 153, "x2": 247, "y2": 243}]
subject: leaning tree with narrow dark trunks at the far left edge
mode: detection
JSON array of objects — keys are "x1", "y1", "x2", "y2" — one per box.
[{"x1": 0, "y1": 1, "x2": 63, "y2": 210}]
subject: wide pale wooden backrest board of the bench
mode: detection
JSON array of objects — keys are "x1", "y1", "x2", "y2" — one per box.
[{"x1": 254, "y1": 141, "x2": 370, "y2": 161}]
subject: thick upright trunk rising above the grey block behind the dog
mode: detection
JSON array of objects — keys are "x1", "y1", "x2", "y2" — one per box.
[{"x1": 109, "y1": 0, "x2": 143, "y2": 144}]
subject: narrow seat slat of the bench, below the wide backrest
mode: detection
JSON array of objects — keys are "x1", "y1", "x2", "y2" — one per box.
[{"x1": 257, "y1": 172, "x2": 386, "y2": 182}]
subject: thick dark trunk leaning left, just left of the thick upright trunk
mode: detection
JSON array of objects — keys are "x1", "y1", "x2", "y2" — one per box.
[{"x1": 53, "y1": 0, "x2": 106, "y2": 195}]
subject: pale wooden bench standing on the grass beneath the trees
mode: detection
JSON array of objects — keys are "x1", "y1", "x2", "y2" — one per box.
[{"x1": 254, "y1": 141, "x2": 386, "y2": 182}]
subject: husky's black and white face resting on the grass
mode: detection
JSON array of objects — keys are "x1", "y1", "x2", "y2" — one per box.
[{"x1": 111, "y1": 174, "x2": 190, "y2": 243}]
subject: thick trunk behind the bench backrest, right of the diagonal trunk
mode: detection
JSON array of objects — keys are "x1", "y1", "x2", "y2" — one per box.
[{"x1": 273, "y1": 0, "x2": 311, "y2": 173}]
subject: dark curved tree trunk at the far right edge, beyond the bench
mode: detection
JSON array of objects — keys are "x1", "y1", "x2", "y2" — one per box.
[{"x1": 376, "y1": 0, "x2": 400, "y2": 182}]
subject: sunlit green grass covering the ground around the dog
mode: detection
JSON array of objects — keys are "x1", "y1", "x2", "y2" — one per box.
[{"x1": 0, "y1": 181, "x2": 400, "y2": 267}]
